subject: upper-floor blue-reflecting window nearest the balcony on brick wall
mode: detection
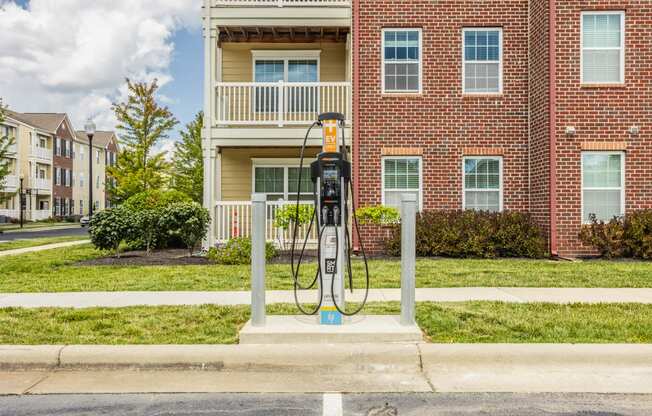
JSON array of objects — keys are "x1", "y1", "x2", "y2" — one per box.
[{"x1": 382, "y1": 29, "x2": 421, "y2": 93}]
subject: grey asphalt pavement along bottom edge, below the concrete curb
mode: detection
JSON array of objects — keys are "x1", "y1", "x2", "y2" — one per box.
[{"x1": 0, "y1": 393, "x2": 652, "y2": 416}]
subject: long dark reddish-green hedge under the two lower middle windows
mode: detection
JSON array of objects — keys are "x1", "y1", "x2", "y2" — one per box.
[{"x1": 386, "y1": 210, "x2": 547, "y2": 258}]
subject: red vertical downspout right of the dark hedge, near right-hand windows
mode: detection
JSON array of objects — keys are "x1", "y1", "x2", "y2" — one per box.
[{"x1": 548, "y1": 0, "x2": 559, "y2": 257}]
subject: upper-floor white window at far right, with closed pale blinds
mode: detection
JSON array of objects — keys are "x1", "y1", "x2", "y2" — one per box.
[{"x1": 581, "y1": 12, "x2": 625, "y2": 84}]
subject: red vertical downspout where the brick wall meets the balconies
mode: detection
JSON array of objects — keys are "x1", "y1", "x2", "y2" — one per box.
[{"x1": 351, "y1": 0, "x2": 360, "y2": 252}]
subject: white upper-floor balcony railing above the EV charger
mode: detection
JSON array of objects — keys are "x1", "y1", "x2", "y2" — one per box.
[{"x1": 215, "y1": 82, "x2": 351, "y2": 127}]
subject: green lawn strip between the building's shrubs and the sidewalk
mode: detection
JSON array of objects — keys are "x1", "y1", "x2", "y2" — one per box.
[{"x1": 0, "y1": 245, "x2": 652, "y2": 293}]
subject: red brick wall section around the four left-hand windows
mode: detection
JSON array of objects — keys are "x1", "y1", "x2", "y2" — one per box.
[{"x1": 357, "y1": 0, "x2": 529, "y2": 247}]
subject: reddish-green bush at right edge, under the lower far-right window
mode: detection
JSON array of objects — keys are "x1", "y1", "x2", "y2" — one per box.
[{"x1": 580, "y1": 209, "x2": 652, "y2": 260}]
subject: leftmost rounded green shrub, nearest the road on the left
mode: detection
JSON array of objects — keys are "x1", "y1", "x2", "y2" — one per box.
[{"x1": 89, "y1": 207, "x2": 133, "y2": 258}]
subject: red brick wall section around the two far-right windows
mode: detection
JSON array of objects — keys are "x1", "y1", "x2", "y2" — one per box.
[{"x1": 556, "y1": 0, "x2": 652, "y2": 256}]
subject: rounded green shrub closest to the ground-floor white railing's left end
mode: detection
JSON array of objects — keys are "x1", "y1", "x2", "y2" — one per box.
[{"x1": 160, "y1": 202, "x2": 211, "y2": 255}]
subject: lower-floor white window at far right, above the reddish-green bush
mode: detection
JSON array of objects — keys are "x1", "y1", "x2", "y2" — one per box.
[{"x1": 582, "y1": 152, "x2": 625, "y2": 223}]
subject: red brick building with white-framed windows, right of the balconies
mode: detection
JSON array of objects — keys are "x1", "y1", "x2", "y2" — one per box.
[{"x1": 353, "y1": 0, "x2": 652, "y2": 256}]
